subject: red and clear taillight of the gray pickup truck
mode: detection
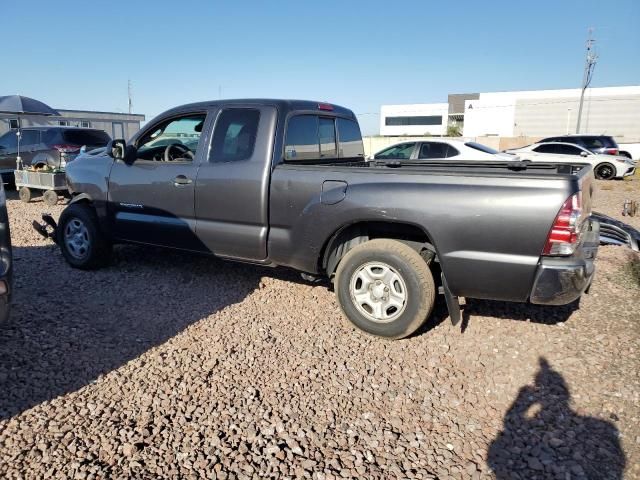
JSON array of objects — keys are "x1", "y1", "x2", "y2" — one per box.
[{"x1": 542, "y1": 192, "x2": 585, "y2": 255}]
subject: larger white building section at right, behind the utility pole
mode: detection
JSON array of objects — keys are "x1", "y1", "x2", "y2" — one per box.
[{"x1": 463, "y1": 86, "x2": 640, "y2": 142}]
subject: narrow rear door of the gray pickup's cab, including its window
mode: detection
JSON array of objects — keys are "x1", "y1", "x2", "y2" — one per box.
[{"x1": 195, "y1": 105, "x2": 277, "y2": 260}]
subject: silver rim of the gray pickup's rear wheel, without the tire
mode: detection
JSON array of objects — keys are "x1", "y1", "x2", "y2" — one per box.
[{"x1": 349, "y1": 262, "x2": 408, "y2": 323}]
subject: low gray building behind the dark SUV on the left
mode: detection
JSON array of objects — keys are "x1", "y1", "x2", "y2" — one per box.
[{"x1": 0, "y1": 110, "x2": 145, "y2": 140}]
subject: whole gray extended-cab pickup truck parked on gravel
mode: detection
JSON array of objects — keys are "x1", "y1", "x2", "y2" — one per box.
[{"x1": 36, "y1": 100, "x2": 598, "y2": 338}]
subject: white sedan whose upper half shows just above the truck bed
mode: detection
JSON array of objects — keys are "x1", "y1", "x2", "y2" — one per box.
[{"x1": 373, "y1": 140, "x2": 517, "y2": 161}]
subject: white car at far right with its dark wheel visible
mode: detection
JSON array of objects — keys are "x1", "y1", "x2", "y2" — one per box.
[{"x1": 507, "y1": 142, "x2": 635, "y2": 180}]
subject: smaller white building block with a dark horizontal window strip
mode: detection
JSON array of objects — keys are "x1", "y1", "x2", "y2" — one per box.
[{"x1": 380, "y1": 103, "x2": 449, "y2": 136}]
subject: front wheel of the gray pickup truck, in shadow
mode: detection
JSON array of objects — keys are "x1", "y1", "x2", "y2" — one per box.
[{"x1": 57, "y1": 204, "x2": 112, "y2": 270}]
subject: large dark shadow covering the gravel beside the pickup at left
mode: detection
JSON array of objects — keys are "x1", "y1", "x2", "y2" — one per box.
[{"x1": 0, "y1": 245, "x2": 308, "y2": 420}]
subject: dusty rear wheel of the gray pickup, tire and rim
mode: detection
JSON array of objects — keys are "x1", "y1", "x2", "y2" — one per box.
[{"x1": 335, "y1": 239, "x2": 436, "y2": 339}]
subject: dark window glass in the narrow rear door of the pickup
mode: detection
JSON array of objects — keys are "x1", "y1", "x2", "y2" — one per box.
[{"x1": 209, "y1": 108, "x2": 260, "y2": 162}]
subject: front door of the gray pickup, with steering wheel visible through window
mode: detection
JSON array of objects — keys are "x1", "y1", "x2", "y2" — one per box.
[{"x1": 108, "y1": 112, "x2": 206, "y2": 251}]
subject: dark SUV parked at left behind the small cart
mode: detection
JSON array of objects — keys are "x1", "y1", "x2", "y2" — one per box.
[{"x1": 0, "y1": 127, "x2": 111, "y2": 182}]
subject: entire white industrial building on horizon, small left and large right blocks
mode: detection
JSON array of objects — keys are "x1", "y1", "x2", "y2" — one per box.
[{"x1": 380, "y1": 86, "x2": 640, "y2": 143}]
